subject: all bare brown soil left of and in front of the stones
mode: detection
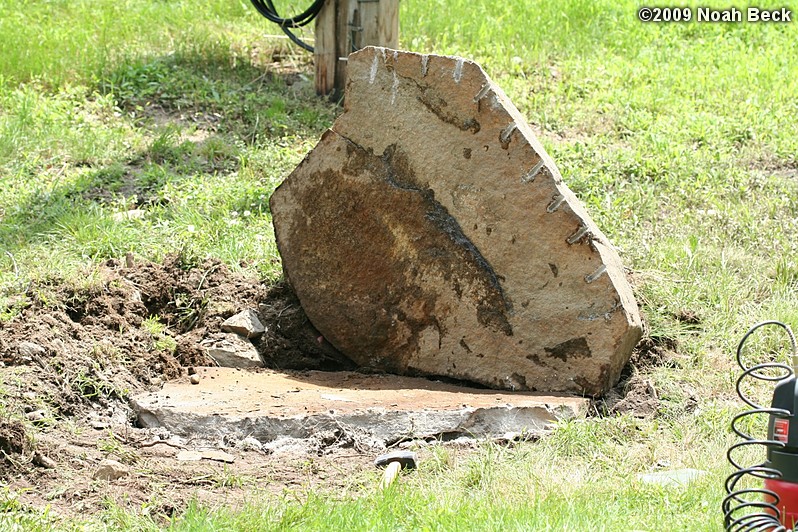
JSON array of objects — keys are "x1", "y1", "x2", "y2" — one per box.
[{"x1": 0, "y1": 255, "x2": 656, "y2": 520}]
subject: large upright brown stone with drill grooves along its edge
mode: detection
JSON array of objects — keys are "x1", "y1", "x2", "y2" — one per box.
[{"x1": 270, "y1": 47, "x2": 641, "y2": 395}]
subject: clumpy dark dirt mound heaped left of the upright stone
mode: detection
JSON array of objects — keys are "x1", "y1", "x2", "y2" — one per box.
[{"x1": 0, "y1": 255, "x2": 351, "y2": 410}]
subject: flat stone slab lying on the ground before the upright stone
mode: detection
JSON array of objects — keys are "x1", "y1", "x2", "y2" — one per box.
[{"x1": 131, "y1": 367, "x2": 588, "y2": 443}]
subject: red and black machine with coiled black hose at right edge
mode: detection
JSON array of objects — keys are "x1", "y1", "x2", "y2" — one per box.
[{"x1": 723, "y1": 321, "x2": 798, "y2": 532}]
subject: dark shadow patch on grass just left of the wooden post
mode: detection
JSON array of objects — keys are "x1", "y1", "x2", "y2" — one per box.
[{"x1": 97, "y1": 48, "x2": 335, "y2": 144}]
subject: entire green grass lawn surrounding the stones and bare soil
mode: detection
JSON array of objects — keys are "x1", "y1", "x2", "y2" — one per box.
[{"x1": 0, "y1": 0, "x2": 798, "y2": 530}]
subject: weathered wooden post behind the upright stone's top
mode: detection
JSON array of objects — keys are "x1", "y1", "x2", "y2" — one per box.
[{"x1": 314, "y1": 0, "x2": 399, "y2": 99}]
